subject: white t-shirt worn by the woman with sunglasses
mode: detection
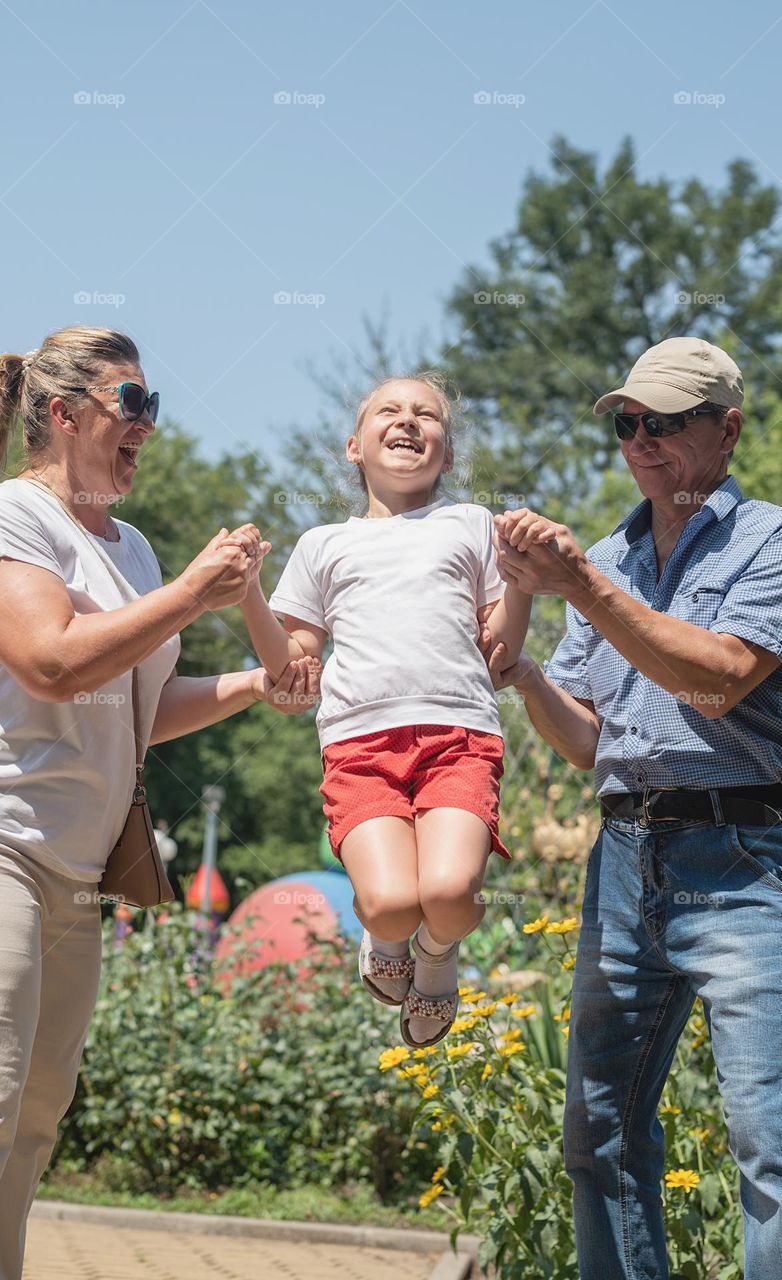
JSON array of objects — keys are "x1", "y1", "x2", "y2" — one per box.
[{"x1": 0, "y1": 479, "x2": 179, "y2": 882}]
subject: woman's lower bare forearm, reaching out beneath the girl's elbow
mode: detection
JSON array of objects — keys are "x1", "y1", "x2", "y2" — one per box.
[{"x1": 150, "y1": 671, "x2": 259, "y2": 746}]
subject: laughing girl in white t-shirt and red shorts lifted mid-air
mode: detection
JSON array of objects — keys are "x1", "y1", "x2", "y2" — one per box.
[{"x1": 242, "y1": 374, "x2": 531, "y2": 1047}]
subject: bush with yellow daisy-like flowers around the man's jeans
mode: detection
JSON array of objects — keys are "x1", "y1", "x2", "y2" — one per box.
[{"x1": 379, "y1": 914, "x2": 742, "y2": 1280}]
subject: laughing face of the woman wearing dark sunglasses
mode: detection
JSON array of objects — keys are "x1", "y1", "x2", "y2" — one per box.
[{"x1": 67, "y1": 365, "x2": 155, "y2": 504}]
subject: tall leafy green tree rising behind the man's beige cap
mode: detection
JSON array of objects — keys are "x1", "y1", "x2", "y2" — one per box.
[{"x1": 443, "y1": 138, "x2": 782, "y2": 522}]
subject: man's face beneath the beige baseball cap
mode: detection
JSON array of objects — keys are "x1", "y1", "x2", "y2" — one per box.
[{"x1": 621, "y1": 399, "x2": 741, "y2": 504}]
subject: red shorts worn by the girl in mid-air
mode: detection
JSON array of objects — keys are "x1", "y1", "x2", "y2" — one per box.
[{"x1": 320, "y1": 724, "x2": 511, "y2": 858}]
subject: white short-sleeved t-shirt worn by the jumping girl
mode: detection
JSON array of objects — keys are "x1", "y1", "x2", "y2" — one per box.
[{"x1": 269, "y1": 498, "x2": 504, "y2": 750}]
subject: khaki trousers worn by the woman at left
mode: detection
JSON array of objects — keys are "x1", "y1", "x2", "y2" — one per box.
[{"x1": 0, "y1": 846, "x2": 101, "y2": 1280}]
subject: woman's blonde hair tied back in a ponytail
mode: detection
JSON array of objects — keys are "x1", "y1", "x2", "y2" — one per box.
[{"x1": 0, "y1": 325, "x2": 140, "y2": 471}]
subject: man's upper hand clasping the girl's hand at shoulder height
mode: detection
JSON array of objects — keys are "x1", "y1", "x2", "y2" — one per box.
[{"x1": 494, "y1": 507, "x2": 591, "y2": 600}]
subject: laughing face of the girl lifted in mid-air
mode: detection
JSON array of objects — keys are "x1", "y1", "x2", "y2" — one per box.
[{"x1": 346, "y1": 378, "x2": 453, "y2": 493}]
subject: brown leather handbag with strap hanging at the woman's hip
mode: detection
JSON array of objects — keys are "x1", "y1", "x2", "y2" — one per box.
[{"x1": 100, "y1": 667, "x2": 174, "y2": 906}]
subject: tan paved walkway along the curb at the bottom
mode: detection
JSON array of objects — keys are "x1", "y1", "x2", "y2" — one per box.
[{"x1": 23, "y1": 1217, "x2": 438, "y2": 1280}]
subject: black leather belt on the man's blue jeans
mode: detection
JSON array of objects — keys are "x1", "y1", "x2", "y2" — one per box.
[{"x1": 600, "y1": 783, "x2": 782, "y2": 827}]
